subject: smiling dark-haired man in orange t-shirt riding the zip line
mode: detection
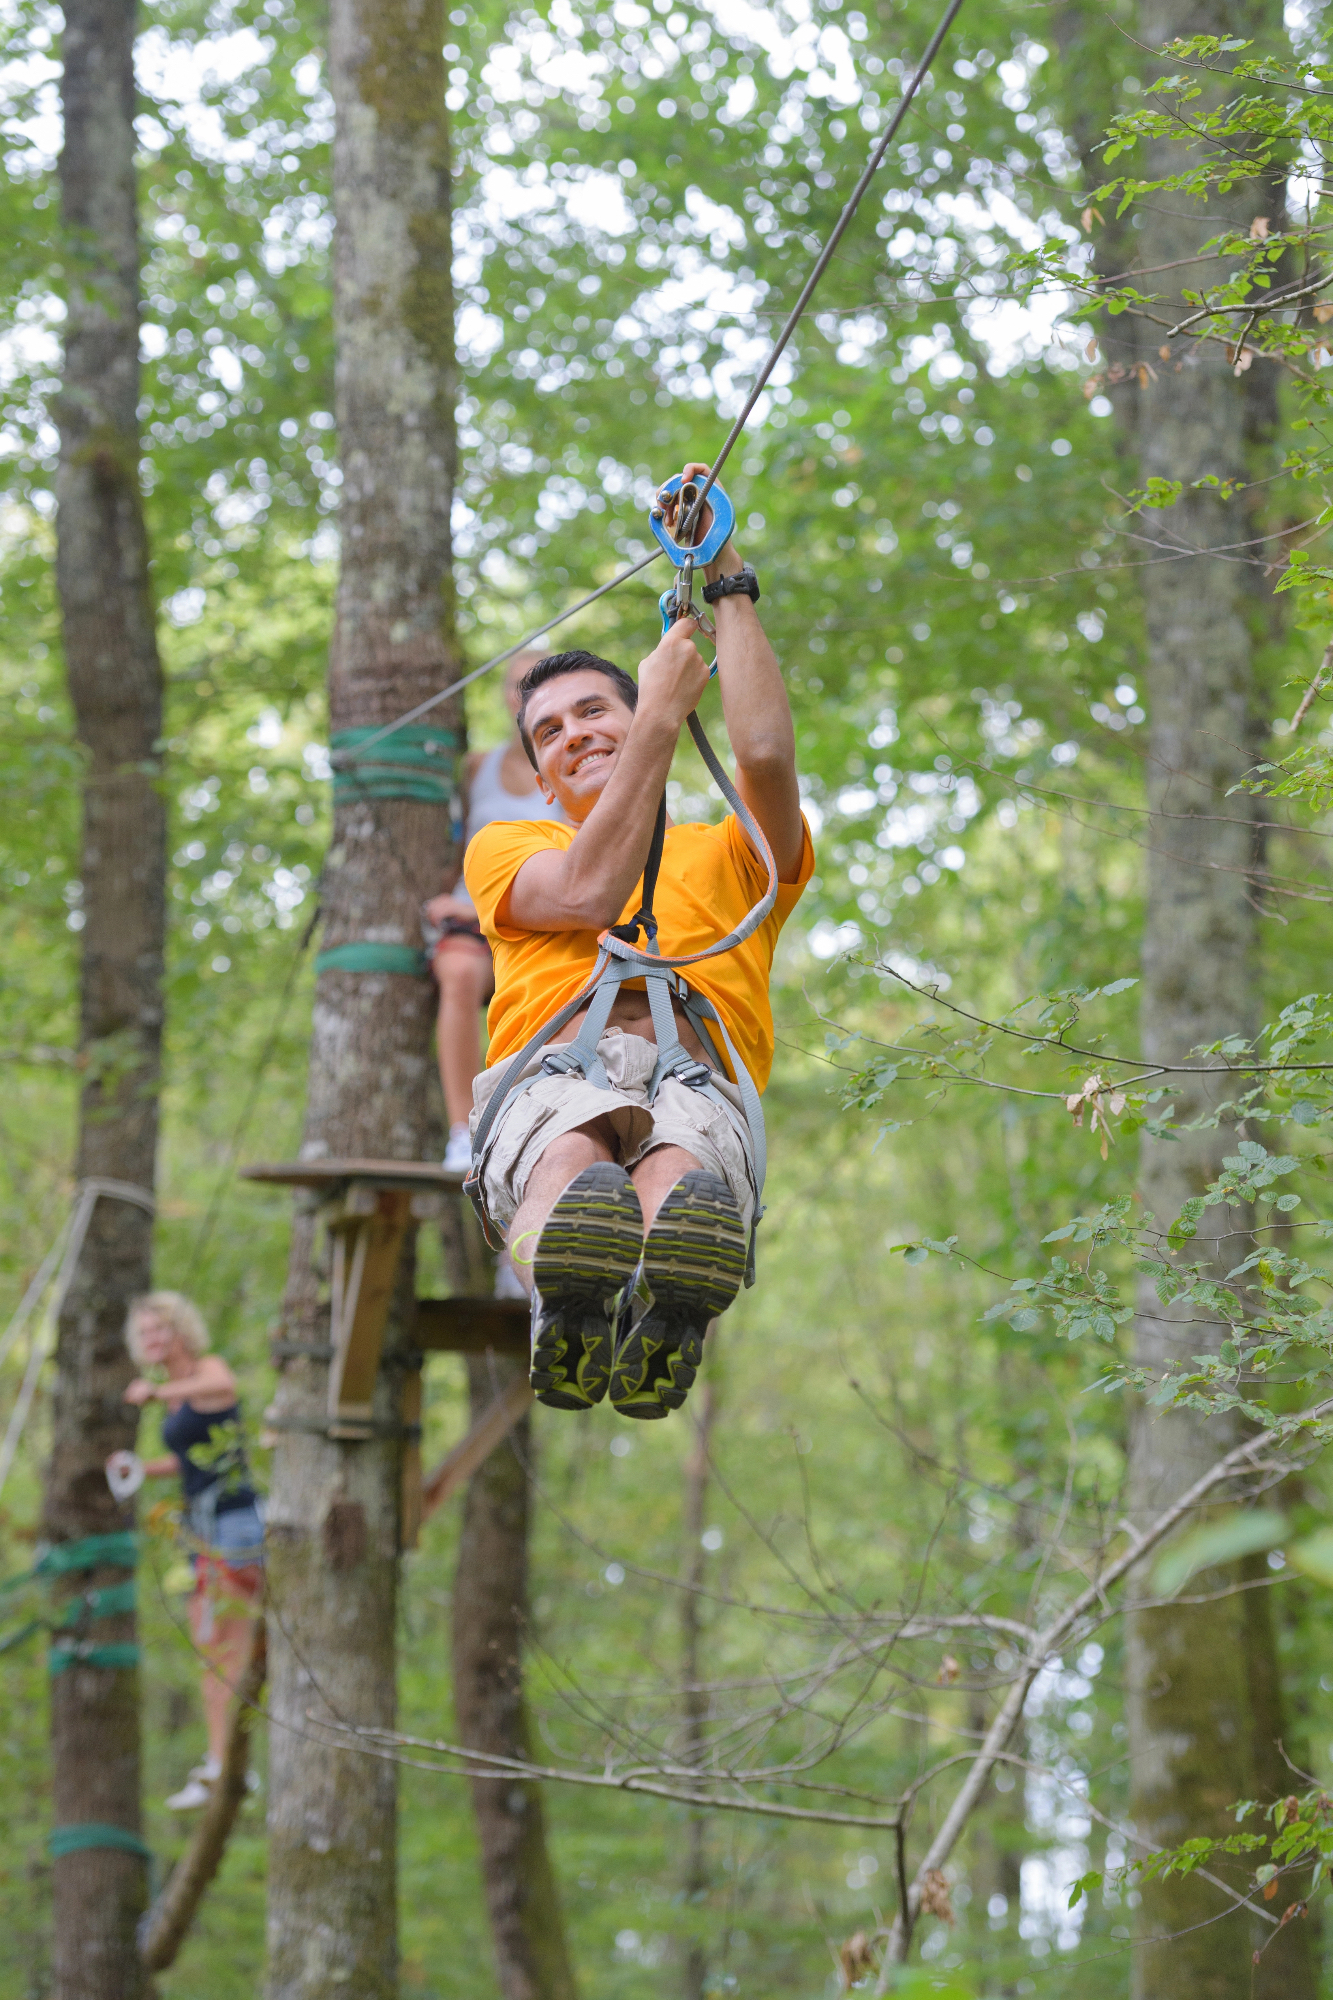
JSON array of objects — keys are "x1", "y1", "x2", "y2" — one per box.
[{"x1": 464, "y1": 466, "x2": 815, "y2": 1418}]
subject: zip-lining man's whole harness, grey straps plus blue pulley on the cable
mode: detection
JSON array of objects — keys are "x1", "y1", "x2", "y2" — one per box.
[{"x1": 462, "y1": 488, "x2": 777, "y2": 1284}]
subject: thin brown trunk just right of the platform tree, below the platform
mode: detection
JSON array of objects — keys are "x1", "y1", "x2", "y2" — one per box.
[{"x1": 454, "y1": 1354, "x2": 578, "y2": 2000}]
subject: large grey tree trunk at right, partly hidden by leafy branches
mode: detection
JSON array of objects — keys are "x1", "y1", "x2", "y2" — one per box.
[{"x1": 1119, "y1": 0, "x2": 1313, "y2": 2000}]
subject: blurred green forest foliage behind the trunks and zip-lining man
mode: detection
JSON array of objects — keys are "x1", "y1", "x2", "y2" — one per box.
[{"x1": 0, "y1": 0, "x2": 1333, "y2": 2000}]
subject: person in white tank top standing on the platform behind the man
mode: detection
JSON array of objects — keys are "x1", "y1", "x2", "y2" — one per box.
[{"x1": 424, "y1": 652, "x2": 566, "y2": 1176}]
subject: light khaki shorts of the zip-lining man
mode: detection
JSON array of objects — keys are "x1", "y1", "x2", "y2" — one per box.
[{"x1": 472, "y1": 1028, "x2": 755, "y2": 1228}]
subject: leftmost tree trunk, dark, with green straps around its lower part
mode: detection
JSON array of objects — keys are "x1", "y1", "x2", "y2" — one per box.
[{"x1": 42, "y1": 0, "x2": 166, "y2": 2000}]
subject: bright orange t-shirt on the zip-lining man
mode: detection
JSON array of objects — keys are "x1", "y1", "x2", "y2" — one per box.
[{"x1": 462, "y1": 814, "x2": 815, "y2": 1090}]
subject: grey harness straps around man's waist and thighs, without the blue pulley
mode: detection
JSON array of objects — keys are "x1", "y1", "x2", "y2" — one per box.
[{"x1": 462, "y1": 714, "x2": 777, "y2": 1284}]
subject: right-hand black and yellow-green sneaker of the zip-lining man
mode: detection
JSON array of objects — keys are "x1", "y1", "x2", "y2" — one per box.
[{"x1": 610, "y1": 1168, "x2": 747, "y2": 1422}]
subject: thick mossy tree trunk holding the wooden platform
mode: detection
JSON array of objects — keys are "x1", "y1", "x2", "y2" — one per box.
[{"x1": 268, "y1": 0, "x2": 460, "y2": 2000}]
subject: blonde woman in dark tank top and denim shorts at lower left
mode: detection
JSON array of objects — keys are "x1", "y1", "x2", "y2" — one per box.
[{"x1": 124, "y1": 1292, "x2": 264, "y2": 1812}]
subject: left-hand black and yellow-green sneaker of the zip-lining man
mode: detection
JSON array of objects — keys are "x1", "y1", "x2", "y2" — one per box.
[{"x1": 532, "y1": 1160, "x2": 642, "y2": 1410}]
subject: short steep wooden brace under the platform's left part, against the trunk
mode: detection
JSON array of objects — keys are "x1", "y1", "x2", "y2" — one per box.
[{"x1": 328, "y1": 1188, "x2": 412, "y2": 1436}]
